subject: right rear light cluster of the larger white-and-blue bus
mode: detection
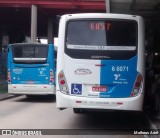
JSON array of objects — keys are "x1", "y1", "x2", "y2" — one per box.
[{"x1": 131, "y1": 73, "x2": 143, "y2": 97}]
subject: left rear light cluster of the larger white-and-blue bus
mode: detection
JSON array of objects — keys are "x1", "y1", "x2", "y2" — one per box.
[{"x1": 58, "y1": 71, "x2": 69, "y2": 94}]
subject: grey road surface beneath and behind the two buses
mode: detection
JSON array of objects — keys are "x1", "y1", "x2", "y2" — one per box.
[{"x1": 0, "y1": 96, "x2": 158, "y2": 138}]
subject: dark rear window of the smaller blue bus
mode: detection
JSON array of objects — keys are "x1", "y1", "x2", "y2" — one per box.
[{"x1": 12, "y1": 44, "x2": 48, "y2": 64}]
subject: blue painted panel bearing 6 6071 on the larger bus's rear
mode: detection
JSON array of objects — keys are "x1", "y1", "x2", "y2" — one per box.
[{"x1": 100, "y1": 56, "x2": 138, "y2": 98}]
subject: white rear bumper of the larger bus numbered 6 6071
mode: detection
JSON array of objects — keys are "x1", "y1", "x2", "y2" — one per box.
[{"x1": 56, "y1": 91, "x2": 144, "y2": 111}]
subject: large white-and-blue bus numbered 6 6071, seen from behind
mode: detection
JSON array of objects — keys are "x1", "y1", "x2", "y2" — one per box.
[{"x1": 56, "y1": 13, "x2": 145, "y2": 113}]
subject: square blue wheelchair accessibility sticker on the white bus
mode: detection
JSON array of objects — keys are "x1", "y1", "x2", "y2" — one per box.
[{"x1": 71, "y1": 83, "x2": 82, "y2": 95}]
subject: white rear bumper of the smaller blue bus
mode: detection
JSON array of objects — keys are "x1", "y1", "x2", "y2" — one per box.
[{"x1": 8, "y1": 84, "x2": 55, "y2": 95}]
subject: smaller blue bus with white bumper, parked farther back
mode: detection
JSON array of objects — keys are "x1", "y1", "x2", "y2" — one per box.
[{"x1": 8, "y1": 43, "x2": 55, "y2": 96}]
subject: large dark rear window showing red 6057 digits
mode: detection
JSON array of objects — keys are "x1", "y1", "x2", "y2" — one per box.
[{"x1": 65, "y1": 19, "x2": 138, "y2": 59}]
